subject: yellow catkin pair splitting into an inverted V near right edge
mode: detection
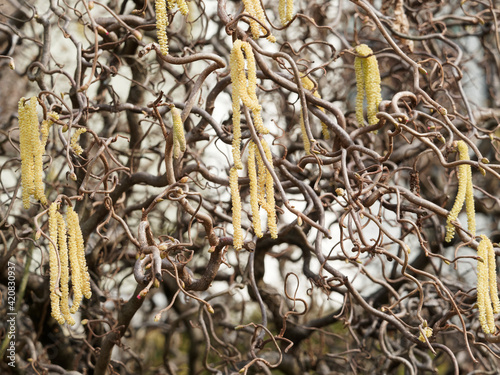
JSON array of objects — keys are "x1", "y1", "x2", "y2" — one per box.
[{"x1": 445, "y1": 141, "x2": 476, "y2": 242}]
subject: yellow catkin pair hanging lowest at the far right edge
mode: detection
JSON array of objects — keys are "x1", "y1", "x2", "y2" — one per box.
[{"x1": 477, "y1": 234, "x2": 500, "y2": 334}]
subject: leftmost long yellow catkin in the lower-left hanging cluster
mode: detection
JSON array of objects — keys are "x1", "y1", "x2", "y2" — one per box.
[{"x1": 49, "y1": 203, "x2": 64, "y2": 324}]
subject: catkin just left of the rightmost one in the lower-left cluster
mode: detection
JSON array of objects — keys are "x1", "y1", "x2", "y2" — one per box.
[{"x1": 66, "y1": 207, "x2": 83, "y2": 314}]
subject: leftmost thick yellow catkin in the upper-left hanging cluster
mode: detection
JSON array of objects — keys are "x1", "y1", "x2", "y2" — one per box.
[{"x1": 18, "y1": 97, "x2": 38, "y2": 209}]
